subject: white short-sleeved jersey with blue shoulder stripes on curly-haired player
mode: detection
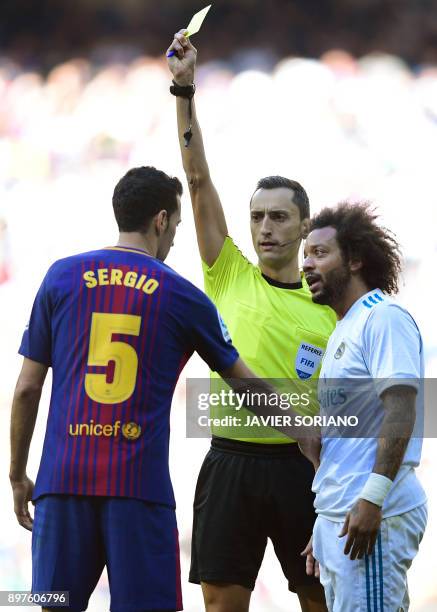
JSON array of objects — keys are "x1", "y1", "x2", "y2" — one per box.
[{"x1": 313, "y1": 289, "x2": 426, "y2": 521}]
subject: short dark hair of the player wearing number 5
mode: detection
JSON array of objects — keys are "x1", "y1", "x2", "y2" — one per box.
[{"x1": 112, "y1": 166, "x2": 182, "y2": 232}]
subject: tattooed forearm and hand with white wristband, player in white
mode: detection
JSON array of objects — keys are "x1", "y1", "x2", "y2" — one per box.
[{"x1": 340, "y1": 385, "x2": 417, "y2": 559}]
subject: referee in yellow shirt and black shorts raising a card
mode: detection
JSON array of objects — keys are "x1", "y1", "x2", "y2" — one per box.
[{"x1": 168, "y1": 31, "x2": 335, "y2": 612}]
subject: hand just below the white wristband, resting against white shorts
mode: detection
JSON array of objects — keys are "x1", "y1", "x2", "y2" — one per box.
[{"x1": 338, "y1": 499, "x2": 382, "y2": 561}]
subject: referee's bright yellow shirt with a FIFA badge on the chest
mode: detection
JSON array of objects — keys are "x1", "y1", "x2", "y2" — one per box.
[{"x1": 202, "y1": 237, "x2": 336, "y2": 444}]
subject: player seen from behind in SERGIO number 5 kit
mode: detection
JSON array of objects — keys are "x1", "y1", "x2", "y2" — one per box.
[{"x1": 10, "y1": 167, "x2": 253, "y2": 612}]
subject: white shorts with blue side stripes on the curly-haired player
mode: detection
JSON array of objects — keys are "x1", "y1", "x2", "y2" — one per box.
[{"x1": 313, "y1": 504, "x2": 428, "y2": 612}]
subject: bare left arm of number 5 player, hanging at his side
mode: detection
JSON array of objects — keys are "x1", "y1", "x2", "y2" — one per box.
[{"x1": 9, "y1": 358, "x2": 48, "y2": 531}]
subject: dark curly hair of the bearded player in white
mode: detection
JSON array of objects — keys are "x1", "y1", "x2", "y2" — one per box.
[{"x1": 310, "y1": 202, "x2": 401, "y2": 295}]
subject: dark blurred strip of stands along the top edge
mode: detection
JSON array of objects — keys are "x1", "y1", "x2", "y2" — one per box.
[{"x1": 0, "y1": 0, "x2": 437, "y2": 67}]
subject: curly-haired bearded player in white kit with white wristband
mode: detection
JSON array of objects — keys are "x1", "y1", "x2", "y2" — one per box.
[{"x1": 304, "y1": 204, "x2": 427, "y2": 612}]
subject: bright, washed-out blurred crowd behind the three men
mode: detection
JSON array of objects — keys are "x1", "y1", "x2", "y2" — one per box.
[{"x1": 0, "y1": 15, "x2": 437, "y2": 612}]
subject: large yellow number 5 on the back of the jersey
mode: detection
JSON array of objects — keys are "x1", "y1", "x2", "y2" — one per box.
[{"x1": 85, "y1": 312, "x2": 141, "y2": 404}]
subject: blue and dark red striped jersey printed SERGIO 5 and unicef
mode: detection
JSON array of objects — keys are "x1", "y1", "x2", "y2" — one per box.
[{"x1": 19, "y1": 247, "x2": 238, "y2": 506}]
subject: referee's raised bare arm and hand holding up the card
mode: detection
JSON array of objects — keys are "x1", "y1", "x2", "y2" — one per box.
[{"x1": 167, "y1": 30, "x2": 228, "y2": 266}]
